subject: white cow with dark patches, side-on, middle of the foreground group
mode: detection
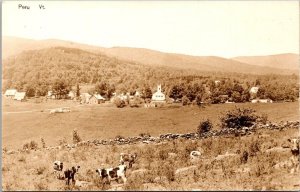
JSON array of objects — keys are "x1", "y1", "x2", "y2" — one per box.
[{"x1": 96, "y1": 165, "x2": 127, "y2": 184}]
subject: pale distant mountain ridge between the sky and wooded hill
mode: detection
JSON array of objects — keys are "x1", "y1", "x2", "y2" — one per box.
[{"x1": 2, "y1": 37, "x2": 299, "y2": 74}]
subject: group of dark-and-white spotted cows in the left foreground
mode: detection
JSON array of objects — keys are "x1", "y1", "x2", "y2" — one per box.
[{"x1": 53, "y1": 153, "x2": 137, "y2": 185}]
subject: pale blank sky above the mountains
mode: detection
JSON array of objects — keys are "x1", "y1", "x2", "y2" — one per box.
[{"x1": 2, "y1": 1, "x2": 299, "y2": 57}]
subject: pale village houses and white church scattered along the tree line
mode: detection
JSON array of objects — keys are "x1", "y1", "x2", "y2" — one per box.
[{"x1": 4, "y1": 84, "x2": 273, "y2": 107}]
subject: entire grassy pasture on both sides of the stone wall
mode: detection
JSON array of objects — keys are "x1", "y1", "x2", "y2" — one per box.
[{"x1": 2, "y1": 100, "x2": 300, "y2": 190}]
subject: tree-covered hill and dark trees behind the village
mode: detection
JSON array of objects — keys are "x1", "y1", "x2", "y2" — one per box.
[{"x1": 3, "y1": 47, "x2": 299, "y2": 103}]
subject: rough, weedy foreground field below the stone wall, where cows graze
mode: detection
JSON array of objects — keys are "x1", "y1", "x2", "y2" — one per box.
[{"x1": 2, "y1": 129, "x2": 300, "y2": 190}]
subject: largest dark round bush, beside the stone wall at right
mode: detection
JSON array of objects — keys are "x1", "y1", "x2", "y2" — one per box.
[{"x1": 220, "y1": 108, "x2": 258, "y2": 129}]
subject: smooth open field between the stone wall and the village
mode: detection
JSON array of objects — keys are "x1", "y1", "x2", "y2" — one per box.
[{"x1": 2, "y1": 100, "x2": 299, "y2": 149}]
